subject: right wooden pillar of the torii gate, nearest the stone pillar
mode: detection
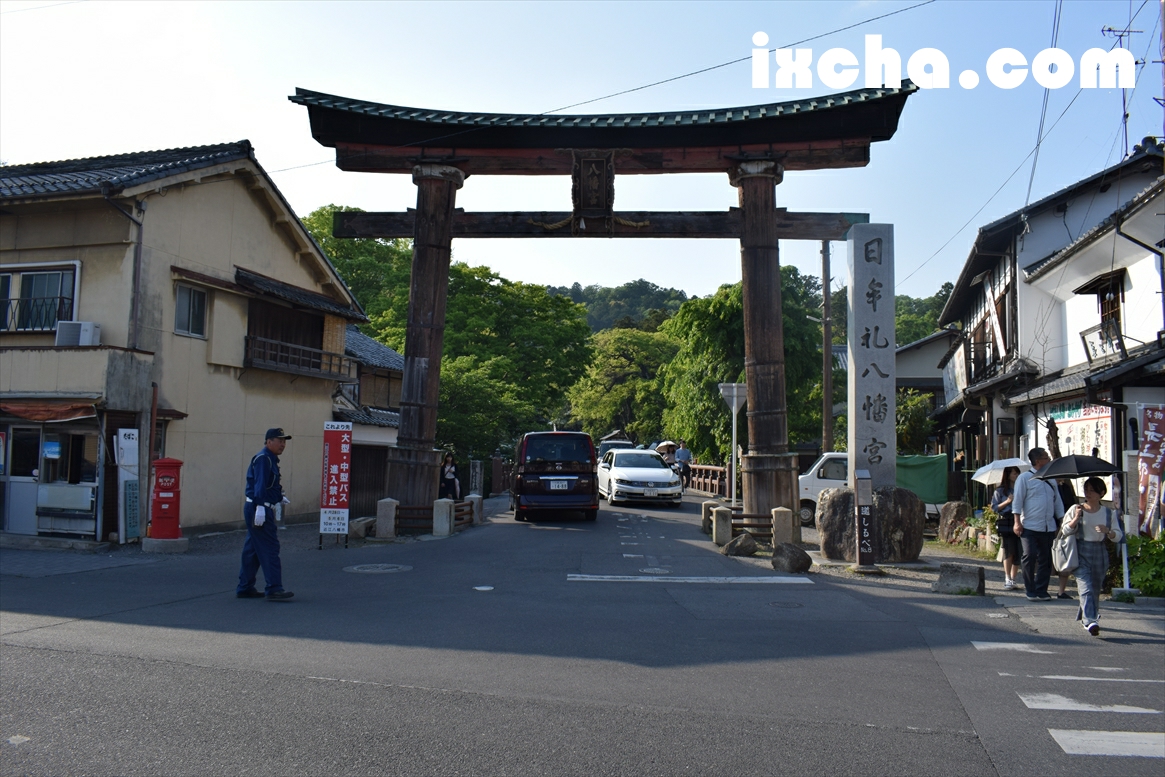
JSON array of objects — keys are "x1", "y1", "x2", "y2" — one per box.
[{"x1": 729, "y1": 161, "x2": 797, "y2": 515}]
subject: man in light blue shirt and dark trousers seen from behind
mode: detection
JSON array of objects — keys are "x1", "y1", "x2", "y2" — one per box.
[{"x1": 1011, "y1": 447, "x2": 1064, "y2": 601}]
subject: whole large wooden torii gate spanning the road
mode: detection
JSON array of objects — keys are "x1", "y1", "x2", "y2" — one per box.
[{"x1": 289, "y1": 82, "x2": 918, "y2": 514}]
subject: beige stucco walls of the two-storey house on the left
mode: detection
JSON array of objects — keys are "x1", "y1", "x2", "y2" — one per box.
[{"x1": 0, "y1": 175, "x2": 358, "y2": 529}]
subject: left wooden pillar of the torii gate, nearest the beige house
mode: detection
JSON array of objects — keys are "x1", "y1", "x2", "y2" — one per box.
[{"x1": 386, "y1": 164, "x2": 465, "y2": 506}]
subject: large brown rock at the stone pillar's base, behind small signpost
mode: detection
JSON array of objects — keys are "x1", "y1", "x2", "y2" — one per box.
[{"x1": 817, "y1": 486, "x2": 926, "y2": 563}]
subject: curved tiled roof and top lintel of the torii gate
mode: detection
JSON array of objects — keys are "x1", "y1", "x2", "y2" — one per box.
[{"x1": 288, "y1": 80, "x2": 918, "y2": 175}]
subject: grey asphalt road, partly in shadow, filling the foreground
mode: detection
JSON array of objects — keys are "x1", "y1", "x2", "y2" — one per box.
[{"x1": 0, "y1": 500, "x2": 1165, "y2": 777}]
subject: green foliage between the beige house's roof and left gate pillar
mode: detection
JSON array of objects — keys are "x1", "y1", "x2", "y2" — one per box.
[{"x1": 303, "y1": 205, "x2": 412, "y2": 323}]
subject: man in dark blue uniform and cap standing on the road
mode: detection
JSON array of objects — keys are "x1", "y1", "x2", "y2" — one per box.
[{"x1": 235, "y1": 428, "x2": 295, "y2": 601}]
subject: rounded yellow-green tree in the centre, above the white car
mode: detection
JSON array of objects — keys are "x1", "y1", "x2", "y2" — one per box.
[{"x1": 569, "y1": 329, "x2": 677, "y2": 443}]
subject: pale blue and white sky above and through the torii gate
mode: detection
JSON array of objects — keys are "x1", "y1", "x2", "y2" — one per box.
[{"x1": 0, "y1": 0, "x2": 1165, "y2": 297}]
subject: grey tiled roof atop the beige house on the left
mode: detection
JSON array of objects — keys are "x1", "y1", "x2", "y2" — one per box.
[{"x1": 0, "y1": 140, "x2": 253, "y2": 199}]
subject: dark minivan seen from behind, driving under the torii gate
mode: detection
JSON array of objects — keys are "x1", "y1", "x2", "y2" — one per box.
[{"x1": 510, "y1": 432, "x2": 599, "y2": 521}]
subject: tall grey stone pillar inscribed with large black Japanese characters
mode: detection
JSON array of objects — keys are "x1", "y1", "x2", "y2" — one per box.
[{"x1": 847, "y1": 224, "x2": 897, "y2": 488}]
